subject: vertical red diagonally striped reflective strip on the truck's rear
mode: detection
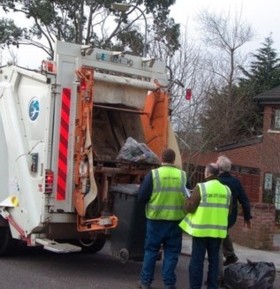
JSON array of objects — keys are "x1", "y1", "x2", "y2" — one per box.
[{"x1": 56, "y1": 88, "x2": 71, "y2": 201}]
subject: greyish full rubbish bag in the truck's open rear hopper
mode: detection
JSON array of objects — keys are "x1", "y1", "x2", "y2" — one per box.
[{"x1": 117, "y1": 137, "x2": 160, "y2": 165}]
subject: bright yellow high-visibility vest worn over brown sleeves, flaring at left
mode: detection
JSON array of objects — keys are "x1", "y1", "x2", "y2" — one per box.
[{"x1": 179, "y1": 180, "x2": 231, "y2": 238}]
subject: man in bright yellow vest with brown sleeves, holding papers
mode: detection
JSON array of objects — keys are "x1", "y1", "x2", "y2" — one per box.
[{"x1": 179, "y1": 163, "x2": 231, "y2": 289}]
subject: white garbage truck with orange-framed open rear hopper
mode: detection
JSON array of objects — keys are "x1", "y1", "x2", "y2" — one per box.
[{"x1": 0, "y1": 41, "x2": 181, "y2": 262}]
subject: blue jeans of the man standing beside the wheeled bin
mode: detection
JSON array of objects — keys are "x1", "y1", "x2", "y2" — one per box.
[{"x1": 140, "y1": 220, "x2": 182, "y2": 288}]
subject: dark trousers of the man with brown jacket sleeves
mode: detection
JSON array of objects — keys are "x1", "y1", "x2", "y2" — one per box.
[{"x1": 189, "y1": 237, "x2": 221, "y2": 289}]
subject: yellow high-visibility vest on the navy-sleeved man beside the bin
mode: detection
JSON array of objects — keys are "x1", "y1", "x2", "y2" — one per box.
[{"x1": 146, "y1": 166, "x2": 186, "y2": 221}]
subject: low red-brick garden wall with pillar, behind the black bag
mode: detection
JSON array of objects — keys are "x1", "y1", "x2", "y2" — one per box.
[{"x1": 230, "y1": 203, "x2": 279, "y2": 250}]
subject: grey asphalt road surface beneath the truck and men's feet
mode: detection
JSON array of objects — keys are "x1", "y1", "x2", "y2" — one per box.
[{"x1": 0, "y1": 241, "x2": 280, "y2": 289}]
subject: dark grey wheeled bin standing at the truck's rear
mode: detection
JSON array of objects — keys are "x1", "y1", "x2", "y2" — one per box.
[{"x1": 110, "y1": 184, "x2": 146, "y2": 263}]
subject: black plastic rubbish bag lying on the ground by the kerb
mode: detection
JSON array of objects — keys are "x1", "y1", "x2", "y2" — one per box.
[{"x1": 224, "y1": 260, "x2": 276, "y2": 289}]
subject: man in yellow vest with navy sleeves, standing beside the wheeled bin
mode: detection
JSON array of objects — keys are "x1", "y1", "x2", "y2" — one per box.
[{"x1": 138, "y1": 149, "x2": 188, "y2": 289}]
